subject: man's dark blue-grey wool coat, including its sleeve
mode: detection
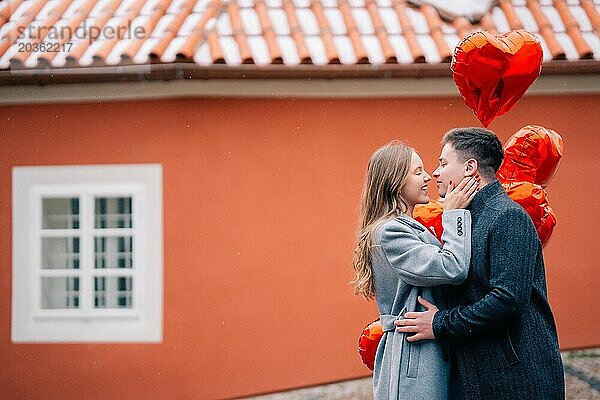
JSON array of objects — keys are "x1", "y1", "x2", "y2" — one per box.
[{"x1": 433, "y1": 180, "x2": 565, "y2": 400}]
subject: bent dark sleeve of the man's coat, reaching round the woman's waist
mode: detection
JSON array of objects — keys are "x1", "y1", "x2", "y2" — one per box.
[{"x1": 433, "y1": 208, "x2": 541, "y2": 339}]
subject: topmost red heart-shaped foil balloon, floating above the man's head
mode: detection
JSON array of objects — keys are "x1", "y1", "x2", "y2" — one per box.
[{"x1": 450, "y1": 29, "x2": 543, "y2": 127}]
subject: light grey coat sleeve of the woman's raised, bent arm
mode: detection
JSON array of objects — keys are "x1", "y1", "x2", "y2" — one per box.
[{"x1": 380, "y1": 210, "x2": 471, "y2": 286}]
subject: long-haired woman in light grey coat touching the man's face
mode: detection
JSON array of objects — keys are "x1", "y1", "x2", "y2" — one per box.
[{"x1": 353, "y1": 141, "x2": 478, "y2": 400}]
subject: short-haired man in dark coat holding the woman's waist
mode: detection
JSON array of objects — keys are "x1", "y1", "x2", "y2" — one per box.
[{"x1": 396, "y1": 128, "x2": 565, "y2": 400}]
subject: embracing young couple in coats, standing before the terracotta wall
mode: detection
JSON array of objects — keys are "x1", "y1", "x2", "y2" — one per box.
[{"x1": 353, "y1": 128, "x2": 565, "y2": 400}]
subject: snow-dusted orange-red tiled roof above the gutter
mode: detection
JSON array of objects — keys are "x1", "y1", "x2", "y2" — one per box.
[{"x1": 0, "y1": 0, "x2": 600, "y2": 69}]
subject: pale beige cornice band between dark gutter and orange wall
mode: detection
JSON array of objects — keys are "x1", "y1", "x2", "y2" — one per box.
[{"x1": 0, "y1": 73, "x2": 600, "y2": 105}]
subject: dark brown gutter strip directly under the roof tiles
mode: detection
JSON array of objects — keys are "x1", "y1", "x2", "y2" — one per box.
[{"x1": 0, "y1": 60, "x2": 600, "y2": 86}]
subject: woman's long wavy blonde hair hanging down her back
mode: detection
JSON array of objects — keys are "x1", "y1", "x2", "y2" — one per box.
[{"x1": 351, "y1": 140, "x2": 414, "y2": 300}]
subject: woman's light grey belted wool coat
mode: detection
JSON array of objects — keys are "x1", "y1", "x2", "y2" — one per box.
[{"x1": 371, "y1": 210, "x2": 471, "y2": 400}]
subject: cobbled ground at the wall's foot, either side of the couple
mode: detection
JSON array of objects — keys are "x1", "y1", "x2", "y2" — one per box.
[{"x1": 245, "y1": 348, "x2": 600, "y2": 400}]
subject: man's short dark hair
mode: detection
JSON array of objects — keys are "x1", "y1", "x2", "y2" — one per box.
[{"x1": 442, "y1": 127, "x2": 504, "y2": 179}]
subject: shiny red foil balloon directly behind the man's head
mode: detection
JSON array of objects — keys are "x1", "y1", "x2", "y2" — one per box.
[{"x1": 498, "y1": 125, "x2": 564, "y2": 188}]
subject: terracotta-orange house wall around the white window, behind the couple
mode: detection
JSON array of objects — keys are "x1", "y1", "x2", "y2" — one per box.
[{"x1": 0, "y1": 96, "x2": 600, "y2": 400}]
